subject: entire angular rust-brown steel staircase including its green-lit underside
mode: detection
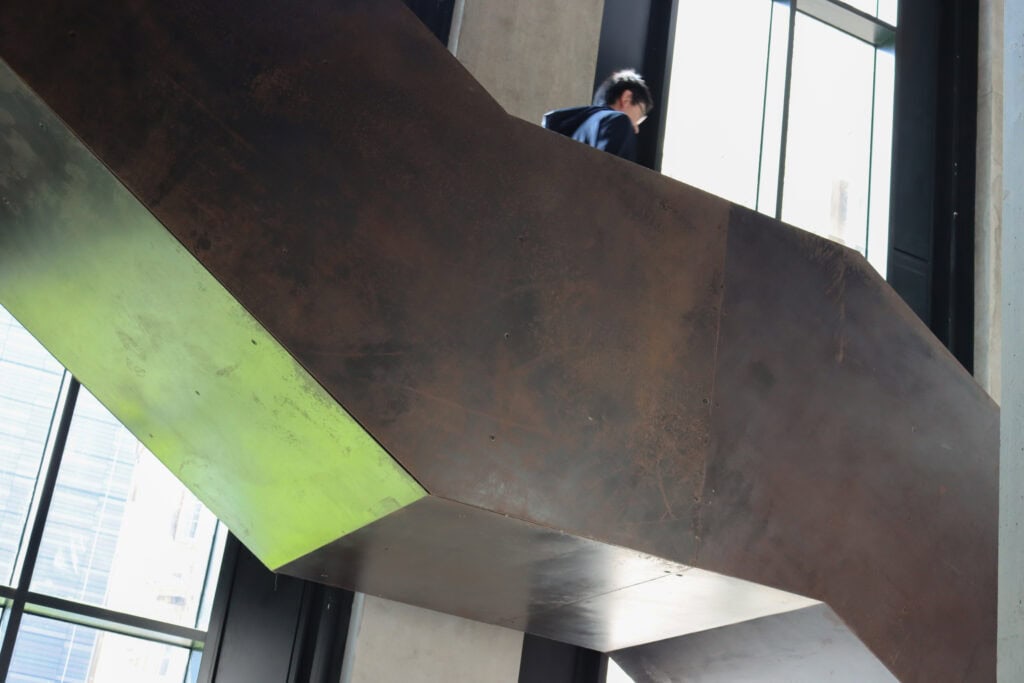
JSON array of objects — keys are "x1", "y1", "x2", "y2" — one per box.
[{"x1": 0, "y1": 0, "x2": 998, "y2": 681}]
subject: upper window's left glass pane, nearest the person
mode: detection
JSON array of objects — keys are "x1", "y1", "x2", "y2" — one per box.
[{"x1": 662, "y1": 0, "x2": 772, "y2": 208}]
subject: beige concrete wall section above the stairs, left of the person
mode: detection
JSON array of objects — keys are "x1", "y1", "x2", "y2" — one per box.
[{"x1": 450, "y1": 0, "x2": 604, "y2": 123}]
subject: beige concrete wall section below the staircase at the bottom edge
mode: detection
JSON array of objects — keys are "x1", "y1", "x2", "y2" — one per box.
[{"x1": 342, "y1": 595, "x2": 522, "y2": 683}]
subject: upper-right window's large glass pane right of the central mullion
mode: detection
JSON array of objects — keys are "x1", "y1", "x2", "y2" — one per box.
[{"x1": 782, "y1": 13, "x2": 874, "y2": 253}]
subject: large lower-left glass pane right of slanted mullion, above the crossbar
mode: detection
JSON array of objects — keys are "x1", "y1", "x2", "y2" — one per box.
[{"x1": 32, "y1": 390, "x2": 216, "y2": 627}]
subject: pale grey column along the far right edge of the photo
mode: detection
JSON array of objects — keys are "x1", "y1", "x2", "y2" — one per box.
[{"x1": 998, "y1": 0, "x2": 1024, "y2": 683}]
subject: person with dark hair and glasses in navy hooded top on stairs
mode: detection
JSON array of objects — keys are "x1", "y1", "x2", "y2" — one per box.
[{"x1": 542, "y1": 69, "x2": 654, "y2": 161}]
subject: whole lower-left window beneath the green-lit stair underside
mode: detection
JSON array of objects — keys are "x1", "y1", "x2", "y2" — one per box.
[{"x1": 0, "y1": 308, "x2": 224, "y2": 683}]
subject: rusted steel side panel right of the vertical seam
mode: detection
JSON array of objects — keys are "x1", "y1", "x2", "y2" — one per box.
[{"x1": 698, "y1": 208, "x2": 998, "y2": 681}]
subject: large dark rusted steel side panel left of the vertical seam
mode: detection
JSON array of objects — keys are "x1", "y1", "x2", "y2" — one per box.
[{"x1": 0, "y1": 0, "x2": 729, "y2": 562}]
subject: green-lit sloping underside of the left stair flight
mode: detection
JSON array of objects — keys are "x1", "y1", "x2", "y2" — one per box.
[{"x1": 0, "y1": 62, "x2": 425, "y2": 568}]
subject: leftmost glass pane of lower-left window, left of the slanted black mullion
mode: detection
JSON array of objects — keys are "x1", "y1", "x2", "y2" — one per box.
[{"x1": 0, "y1": 308, "x2": 63, "y2": 586}]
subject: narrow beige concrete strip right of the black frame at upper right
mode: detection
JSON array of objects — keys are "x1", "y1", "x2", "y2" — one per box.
[{"x1": 974, "y1": 0, "x2": 1004, "y2": 402}]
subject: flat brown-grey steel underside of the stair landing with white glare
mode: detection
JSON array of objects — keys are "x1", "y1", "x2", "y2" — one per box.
[{"x1": 281, "y1": 496, "x2": 816, "y2": 651}]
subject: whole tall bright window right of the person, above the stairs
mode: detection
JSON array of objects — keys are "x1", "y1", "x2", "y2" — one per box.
[{"x1": 662, "y1": 0, "x2": 896, "y2": 274}]
